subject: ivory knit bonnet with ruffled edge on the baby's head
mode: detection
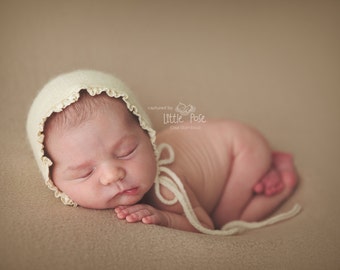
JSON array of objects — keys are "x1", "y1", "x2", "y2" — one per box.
[{"x1": 26, "y1": 70, "x2": 158, "y2": 206}]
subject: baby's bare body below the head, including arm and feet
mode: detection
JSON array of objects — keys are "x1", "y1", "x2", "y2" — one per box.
[{"x1": 115, "y1": 120, "x2": 297, "y2": 230}]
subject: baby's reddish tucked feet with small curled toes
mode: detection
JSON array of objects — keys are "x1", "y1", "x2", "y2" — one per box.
[{"x1": 253, "y1": 152, "x2": 297, "y2": 196}]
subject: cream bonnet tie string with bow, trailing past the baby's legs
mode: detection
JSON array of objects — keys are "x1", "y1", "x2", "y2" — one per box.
[{"x1": 155, "y1": 143, "x2": 301, "y2": 235}]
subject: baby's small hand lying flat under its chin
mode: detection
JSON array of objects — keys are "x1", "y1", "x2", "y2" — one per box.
[{"x1": 115, "y1": 204, "x2": 168, "y2": 226}]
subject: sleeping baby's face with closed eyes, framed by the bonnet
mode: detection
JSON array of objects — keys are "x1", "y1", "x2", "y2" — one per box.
[{"x1": 45, "y1": 102, "x2": 157, "y2": 209}]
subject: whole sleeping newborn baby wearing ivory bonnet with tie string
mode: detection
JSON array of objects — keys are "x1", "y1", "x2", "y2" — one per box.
[{"x1": 27, "y1": 71, "x2": 300, "y2": 235}]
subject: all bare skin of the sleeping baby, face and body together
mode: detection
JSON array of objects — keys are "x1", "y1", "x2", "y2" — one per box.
[{"x1": 44, "y1": 98, "x2": 297, "y2": 231}]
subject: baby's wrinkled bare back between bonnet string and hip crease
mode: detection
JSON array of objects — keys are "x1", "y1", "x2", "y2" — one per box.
[{"x1": 157, "y1": 121, "x2": 233, "y2": 213}]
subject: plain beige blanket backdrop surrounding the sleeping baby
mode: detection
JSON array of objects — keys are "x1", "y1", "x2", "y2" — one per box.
[{"x1": 0, "y1": 0, "x2": 340, "y2": 270}]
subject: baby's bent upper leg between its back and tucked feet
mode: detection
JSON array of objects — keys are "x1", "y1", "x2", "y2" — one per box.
[{"x1": 212, "y1": 126, "x2": 272, "y2": 228}]
